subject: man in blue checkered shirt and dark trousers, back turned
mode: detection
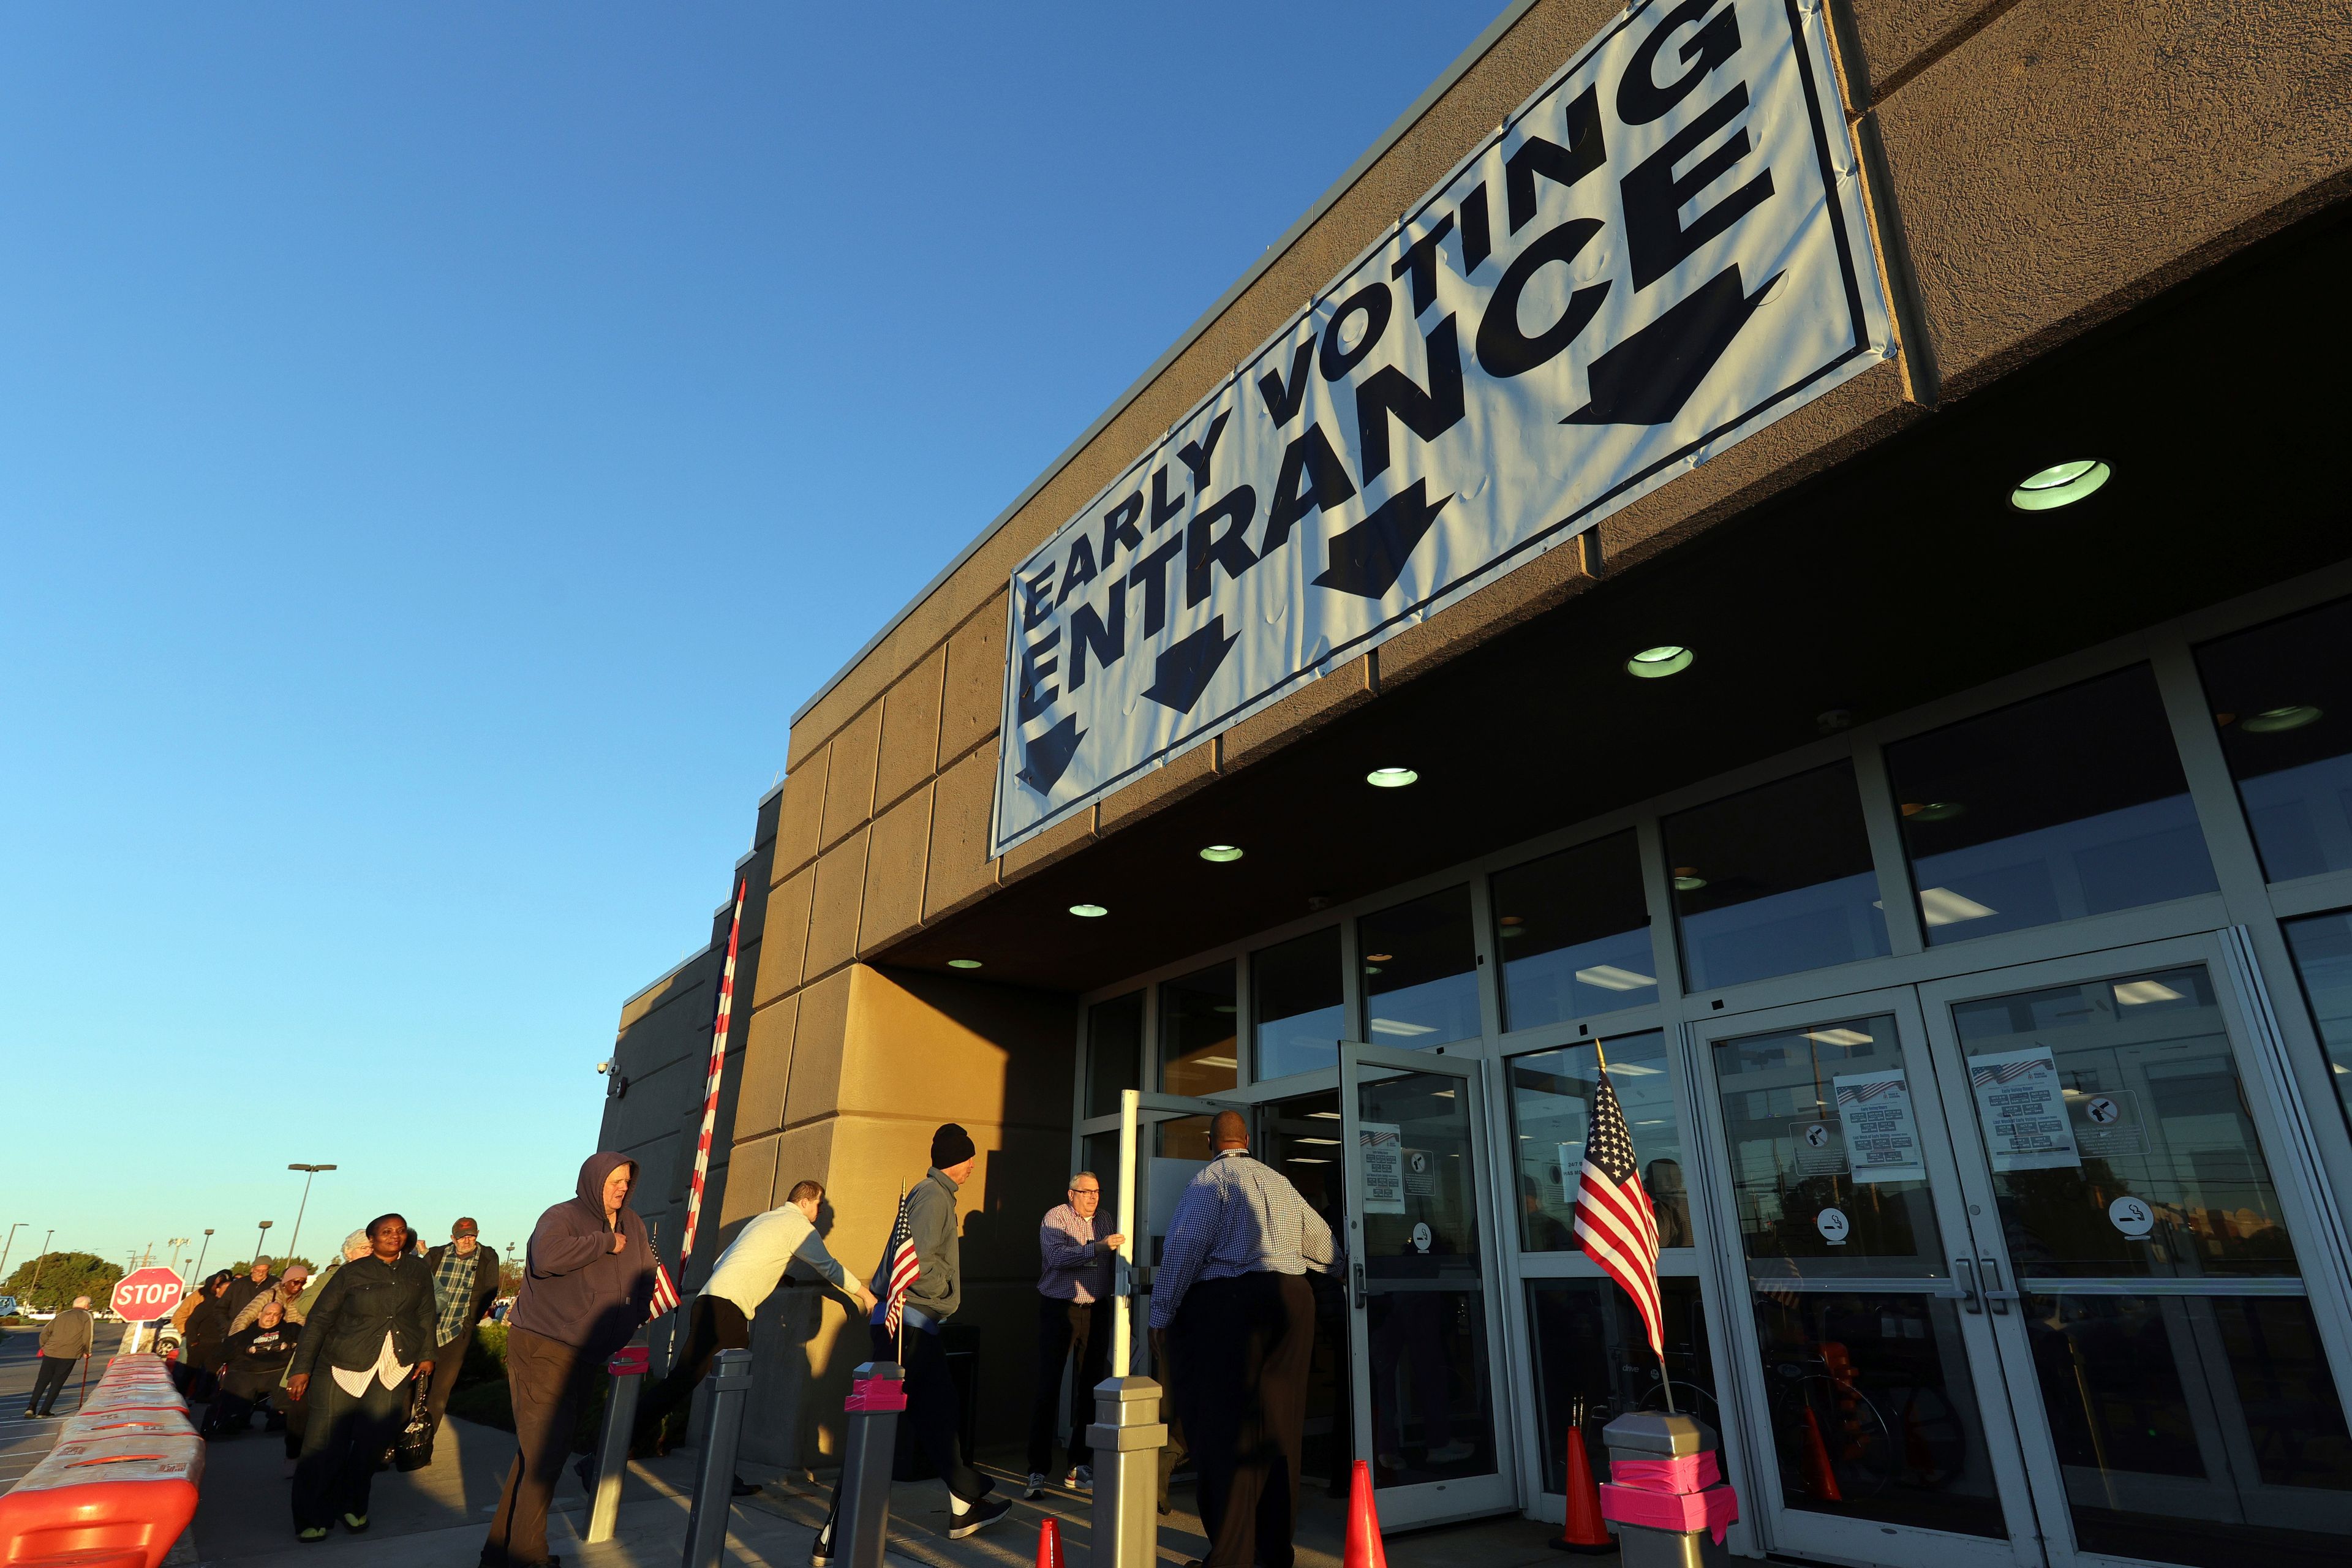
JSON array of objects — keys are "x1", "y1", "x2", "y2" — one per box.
[{"x1": 1153, "y1": 1110, "x2": 1338, "y2": 1568}]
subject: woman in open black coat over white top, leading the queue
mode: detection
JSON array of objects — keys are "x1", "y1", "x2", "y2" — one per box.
[{"x1": 287, "y1": 1213, "x2": 437, "y2": 1540}]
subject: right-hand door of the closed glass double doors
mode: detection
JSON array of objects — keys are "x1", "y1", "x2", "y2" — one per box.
[{"x1": 1921, "y1": 936, "x2": 2352, "y2": 1568}]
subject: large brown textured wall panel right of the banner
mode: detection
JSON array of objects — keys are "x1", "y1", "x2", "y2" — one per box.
[{"x1": 1877, "y1": 0, "x2": 2352, "y2": 395}]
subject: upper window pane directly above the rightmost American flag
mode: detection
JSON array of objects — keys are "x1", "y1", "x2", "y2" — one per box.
[{"x1": 1491, "y1": 832, "x2": 1658, "y2": 1030}]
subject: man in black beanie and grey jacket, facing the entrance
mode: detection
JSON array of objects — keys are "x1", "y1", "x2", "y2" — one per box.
[{"x1": 809, "y1": 1121, "x2": 1011, "y2": 1563}]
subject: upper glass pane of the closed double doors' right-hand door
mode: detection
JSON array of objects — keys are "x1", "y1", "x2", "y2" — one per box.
[{"x1": 1952, "y1": 966, "x2": 2298, "y2": 1279}]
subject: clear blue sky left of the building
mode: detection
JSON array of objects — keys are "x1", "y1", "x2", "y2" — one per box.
[{"x1": 0, "y1": 0, "x2": 1501, "y2": 1267}]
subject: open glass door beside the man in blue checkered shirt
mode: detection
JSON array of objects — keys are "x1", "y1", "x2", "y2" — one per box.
[{"x1": 1338, "y1": 1044, "x2": 1517, "y2": 1531}]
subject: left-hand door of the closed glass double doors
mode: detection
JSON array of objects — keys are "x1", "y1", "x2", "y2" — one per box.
[{"x1": 1696, "y1": 990, "x2": 2041, "y2": 1568}]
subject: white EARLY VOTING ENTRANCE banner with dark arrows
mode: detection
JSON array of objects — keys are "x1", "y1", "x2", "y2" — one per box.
[{"x1": 992, "y1": 0, "x2": 1893, "y2": 853}]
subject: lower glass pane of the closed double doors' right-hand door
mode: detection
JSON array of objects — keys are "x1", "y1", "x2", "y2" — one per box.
[{"x1": 2022, "y1": 1288, "x2": 2352, "y2": 1568}]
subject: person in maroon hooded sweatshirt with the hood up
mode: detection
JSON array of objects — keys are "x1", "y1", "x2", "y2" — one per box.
[{"x1": 482, "y1": 1152, "x2": 654, "y2": 1568}]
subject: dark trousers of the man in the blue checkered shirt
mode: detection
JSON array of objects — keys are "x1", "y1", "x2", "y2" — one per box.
[{"x1": 1169, "y1": 1274, "x2": 1315, "y2": 1568}]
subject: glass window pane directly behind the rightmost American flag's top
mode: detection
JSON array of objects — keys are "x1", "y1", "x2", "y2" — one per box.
[{"x1": 1507, "y1": 1030, "x2": 1691, "y2": 1260}]
